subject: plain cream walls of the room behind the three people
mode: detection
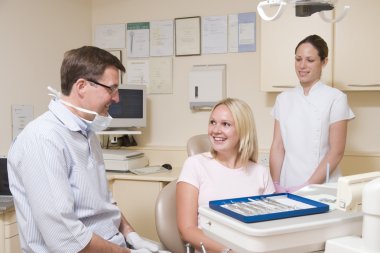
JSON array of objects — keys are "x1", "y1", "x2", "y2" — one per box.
[{"x1": 0, "y1": 0, "x2": 380, "y2": 160}]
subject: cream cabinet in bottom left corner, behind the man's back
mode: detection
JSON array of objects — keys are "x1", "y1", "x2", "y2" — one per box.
[{"x1": 0, "y1": 208, "x2": 21, "y2": 253}]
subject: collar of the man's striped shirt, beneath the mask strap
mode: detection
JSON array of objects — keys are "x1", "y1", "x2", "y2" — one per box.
[{"x1": 49, "y1": 99, "x2": 88, "y2": 135}]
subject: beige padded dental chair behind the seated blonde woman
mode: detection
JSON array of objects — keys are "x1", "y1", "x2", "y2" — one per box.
[{"x1": 155, "y1": 134, "x2": 211, "y2": 253}]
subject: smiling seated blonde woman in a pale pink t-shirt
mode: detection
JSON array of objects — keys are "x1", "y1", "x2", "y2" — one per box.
[{"x1": 177, "y1": 98, "x2": 274, "y2": 253}]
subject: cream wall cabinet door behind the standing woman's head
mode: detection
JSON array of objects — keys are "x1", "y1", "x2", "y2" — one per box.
[{"x1": 259, "y1": 3, "x2": 333, "y2": 91}]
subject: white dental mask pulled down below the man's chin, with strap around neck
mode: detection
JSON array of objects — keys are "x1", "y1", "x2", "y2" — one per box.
[{"x1": 48, "y1": 86, "x2": 112, "y2": 132}]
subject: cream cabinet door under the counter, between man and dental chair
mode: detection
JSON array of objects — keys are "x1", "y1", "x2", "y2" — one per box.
[{"x1": 111, "y1": 179, "x2": 164, "y2": 241}]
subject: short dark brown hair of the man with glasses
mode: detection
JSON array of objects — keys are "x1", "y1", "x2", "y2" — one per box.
[{"x1": 61, "y1": 46, "x2": 125, "y2": 96}]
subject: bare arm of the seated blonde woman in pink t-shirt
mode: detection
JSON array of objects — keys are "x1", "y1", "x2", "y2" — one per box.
[{"x1": 176, "y1": 182, "x2": 232, "y2": 253}]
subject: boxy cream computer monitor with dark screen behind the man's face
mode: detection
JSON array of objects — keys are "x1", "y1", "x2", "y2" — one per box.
[{"x1": 108, "y1": 84, "x2": 147, "y2": 129}]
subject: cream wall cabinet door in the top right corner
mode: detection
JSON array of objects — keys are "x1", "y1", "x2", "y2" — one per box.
[{"x1": 334, "y1": 0, "x2": 380, "y2": 90}]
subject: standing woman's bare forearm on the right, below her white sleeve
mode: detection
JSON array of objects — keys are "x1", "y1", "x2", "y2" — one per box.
[{"x1": 308, "y1": 120, "x2": 347, "y2": 184}]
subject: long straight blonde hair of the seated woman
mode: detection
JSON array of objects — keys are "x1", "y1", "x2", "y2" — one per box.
[{"x1": 210, "y1": 98, "x2": 258, "y2": 167}]
